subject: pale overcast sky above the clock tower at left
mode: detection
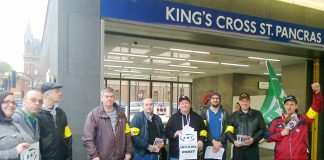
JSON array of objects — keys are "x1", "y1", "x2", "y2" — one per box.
[{"x1": 0, "y1": 0, "x2": 47, "y2": 72}]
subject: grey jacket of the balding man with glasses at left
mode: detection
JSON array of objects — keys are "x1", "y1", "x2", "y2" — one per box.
[{"x1": 12, "y1": 108, "x2": 39, "y2": 142}]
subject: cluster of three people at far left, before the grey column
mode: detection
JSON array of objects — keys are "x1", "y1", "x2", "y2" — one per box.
[{"x1": 0, "y1": 82, "x2": 72, "y2": 160}]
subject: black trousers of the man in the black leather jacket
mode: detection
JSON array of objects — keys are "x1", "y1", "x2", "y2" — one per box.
[{"x1": 233, "y1": 145, "x2": 260, "y2": 160}]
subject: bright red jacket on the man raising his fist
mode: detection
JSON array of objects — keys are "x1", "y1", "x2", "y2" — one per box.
[{"x1": 265, "y1": 93, "x2": 322, "y2": 160}]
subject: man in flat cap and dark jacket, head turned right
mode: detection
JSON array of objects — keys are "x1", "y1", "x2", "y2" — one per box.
[{"x1": 37, "y1": 82, "x2": 72, "y2": 160}]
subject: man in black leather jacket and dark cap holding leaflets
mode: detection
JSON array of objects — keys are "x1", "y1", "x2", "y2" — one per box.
[{"x1": 225, "y1": 93, "x2": 266, "y2": 160}]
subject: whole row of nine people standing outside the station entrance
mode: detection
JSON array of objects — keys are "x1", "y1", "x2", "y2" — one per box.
[{"x1": 0, "y1": 83, "x2": 323, "y2": 160}]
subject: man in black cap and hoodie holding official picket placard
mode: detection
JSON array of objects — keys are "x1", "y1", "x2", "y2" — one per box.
[{"x1": 165, "y1": 96, "x2": 207, "y2": 160}]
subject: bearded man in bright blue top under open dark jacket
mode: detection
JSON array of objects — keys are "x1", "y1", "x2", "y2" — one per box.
[{"x1": 200, "y1": 92, "x2": 229, "y2": 160}]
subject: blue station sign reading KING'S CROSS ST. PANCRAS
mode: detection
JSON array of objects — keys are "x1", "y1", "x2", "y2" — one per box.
[{"x1": 100, "y1": 0, "x2": 324, "y2": 50}]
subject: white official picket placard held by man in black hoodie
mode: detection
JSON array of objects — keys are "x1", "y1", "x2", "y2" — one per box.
[{"x1": 179, "y1": 130, "x2": 198, "y2": 159}]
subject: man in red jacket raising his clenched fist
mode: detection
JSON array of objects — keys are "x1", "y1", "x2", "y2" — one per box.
[{"x1": 265, "y1": 83, "x2": 323, "y2": 160}]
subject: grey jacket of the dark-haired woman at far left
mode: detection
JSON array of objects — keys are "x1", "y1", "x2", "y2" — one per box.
[{"x1": 0, "y1": 121, "x2": 33, "y2": 160}]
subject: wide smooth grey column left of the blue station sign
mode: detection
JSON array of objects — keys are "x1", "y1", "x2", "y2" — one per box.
[{"x1": 55, "y1": 0, "x2": 102, "y2": 160}]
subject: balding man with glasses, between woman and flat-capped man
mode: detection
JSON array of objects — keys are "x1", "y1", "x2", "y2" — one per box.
[{"x1": 12, "y1": 90, "x2": 43, "y2": 142}]
